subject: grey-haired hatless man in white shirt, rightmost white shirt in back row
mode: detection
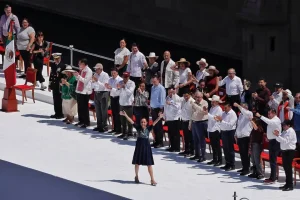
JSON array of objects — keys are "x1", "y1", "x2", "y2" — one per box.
[{"x1": 219, "y1": 68, "x2": 244, "y2": 113}]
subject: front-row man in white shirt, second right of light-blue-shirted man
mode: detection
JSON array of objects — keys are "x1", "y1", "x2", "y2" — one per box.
[{"x1": 179, "y1": 93, "x2": 195, "y2": 156}]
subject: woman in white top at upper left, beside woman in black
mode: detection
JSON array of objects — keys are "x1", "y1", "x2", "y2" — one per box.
[{"x1": 16, "y1": 18, "x2": 35, "y2": 78}]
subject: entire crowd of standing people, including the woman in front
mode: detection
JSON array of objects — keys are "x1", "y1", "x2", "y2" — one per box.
[{"x1": 0, "y1": 3, "x2": 300, "y2": 191}]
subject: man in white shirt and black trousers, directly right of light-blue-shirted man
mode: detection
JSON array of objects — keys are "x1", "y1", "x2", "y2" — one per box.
[{"x1": 164, "y1": 87, "x2": 181, "y2": 152}]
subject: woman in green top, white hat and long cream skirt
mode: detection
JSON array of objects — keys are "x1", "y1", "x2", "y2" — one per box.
[{"x1": 60, "y1": 65, "x2": 77, "y2": 124}]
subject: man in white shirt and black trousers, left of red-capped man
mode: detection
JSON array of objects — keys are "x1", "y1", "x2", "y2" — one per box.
[{"x1": 105, "y1": 68, "x2": 123, "y2": 135}]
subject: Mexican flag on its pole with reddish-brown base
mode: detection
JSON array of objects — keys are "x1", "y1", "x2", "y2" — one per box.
[{"x1": 2, "y1": 20, "x2": 18, "y2": 112}]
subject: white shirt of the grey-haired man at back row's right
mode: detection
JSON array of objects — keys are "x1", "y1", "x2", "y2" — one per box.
[{"x1": 219, "y1": 76, "x2": 244, "y2": 95}]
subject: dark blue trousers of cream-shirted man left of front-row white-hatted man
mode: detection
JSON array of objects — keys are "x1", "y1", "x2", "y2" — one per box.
[{"x1": 192, "y1": 121, "x2": 207, "y2": 158}]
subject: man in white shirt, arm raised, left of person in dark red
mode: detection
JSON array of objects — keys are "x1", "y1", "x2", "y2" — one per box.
[{"x1": 233, "y1": 103, "x2": 253, "y2": 176}]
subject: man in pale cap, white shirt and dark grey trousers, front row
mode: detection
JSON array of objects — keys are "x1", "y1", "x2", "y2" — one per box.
[{"x1": 92, "y1": 63, "x2": 109, "y2": 132}]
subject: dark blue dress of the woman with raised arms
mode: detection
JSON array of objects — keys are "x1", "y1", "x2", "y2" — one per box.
[{"x1": 132, "y1": 124, "x2": 154, "y2": 166}]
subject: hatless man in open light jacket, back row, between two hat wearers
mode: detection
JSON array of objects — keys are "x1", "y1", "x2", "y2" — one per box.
[{"x1": 160, "y1": 51, "x2": 179, "y2": 90}]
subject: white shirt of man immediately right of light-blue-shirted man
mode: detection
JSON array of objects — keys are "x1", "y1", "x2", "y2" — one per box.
[{"x1": 164, "y1": 95, "x2": 181, "y2": 121}]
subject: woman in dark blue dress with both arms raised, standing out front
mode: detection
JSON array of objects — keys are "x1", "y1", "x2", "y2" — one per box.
[{"x1": 120, "y1": 111, "x2": 163, "y2": 186}]
